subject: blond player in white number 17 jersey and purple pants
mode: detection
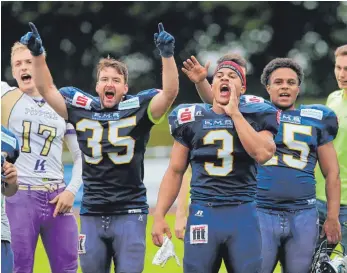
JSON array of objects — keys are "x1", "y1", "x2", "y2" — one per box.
[{"x1": 1, "y1": 42, "x2": 82, "y2": 273}]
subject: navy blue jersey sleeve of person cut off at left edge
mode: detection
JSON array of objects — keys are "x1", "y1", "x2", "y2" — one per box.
[{"x1": 1, "y1": 125, "x2": 19, "y2": 181}]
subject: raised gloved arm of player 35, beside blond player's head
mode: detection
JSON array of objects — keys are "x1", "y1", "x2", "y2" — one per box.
[{"x1": 20, "y1": 22, "x2": 68, "y2": 120}]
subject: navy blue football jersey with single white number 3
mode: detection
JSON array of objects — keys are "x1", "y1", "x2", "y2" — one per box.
[{"x1": 169, "y1": 96, "x2": 279, "y2": 205}]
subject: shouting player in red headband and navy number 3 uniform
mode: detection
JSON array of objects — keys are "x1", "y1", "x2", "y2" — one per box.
[{"x1": 152, "y1": 53, "x2": 278, "y2": 273}]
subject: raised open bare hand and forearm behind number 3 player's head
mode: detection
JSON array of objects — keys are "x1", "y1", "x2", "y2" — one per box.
[{"x1": 182, "y1": 56, "x2": 213, "y2": 104}]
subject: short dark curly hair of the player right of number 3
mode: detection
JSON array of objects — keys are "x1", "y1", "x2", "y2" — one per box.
[{"x1": 260, "y1": 58, "x2": 304, "y2": 87}]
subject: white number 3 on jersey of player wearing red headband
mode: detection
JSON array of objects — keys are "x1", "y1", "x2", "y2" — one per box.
[{"x1": 203, "y1": 130, "x2": 234, "y2": 176}]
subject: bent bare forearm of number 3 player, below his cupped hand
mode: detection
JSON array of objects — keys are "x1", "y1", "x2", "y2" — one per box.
[{"x1": 232, "y1": 113, "x2": 276, "y2": 164}]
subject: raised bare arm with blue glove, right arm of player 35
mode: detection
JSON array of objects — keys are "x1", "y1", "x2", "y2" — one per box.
[{"x1": 150, "y1": 23, "x2": 179, "y2": 120}]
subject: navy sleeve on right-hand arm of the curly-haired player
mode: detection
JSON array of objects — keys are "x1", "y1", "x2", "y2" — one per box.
[{"x1": 318, "y1": 106, "x2": 339, "y2": 146}]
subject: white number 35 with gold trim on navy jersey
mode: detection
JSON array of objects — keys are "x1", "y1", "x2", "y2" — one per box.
[{"x1": 76, "y1": 116, "x2": 136, "y2": 164}]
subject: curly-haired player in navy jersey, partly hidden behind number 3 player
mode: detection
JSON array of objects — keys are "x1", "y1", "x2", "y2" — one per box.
[{"x1": 257, "y1": 58, "x2": 341, "y2": 273}]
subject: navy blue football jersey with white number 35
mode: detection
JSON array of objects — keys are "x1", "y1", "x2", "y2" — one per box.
[{"x1": 60, "y1": 87, "x2": 158, "y2": 214}]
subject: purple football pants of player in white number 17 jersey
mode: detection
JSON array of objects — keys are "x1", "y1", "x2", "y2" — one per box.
[{"x1": 6, "y1": 188, "x2": 78, "y2": 273}]
